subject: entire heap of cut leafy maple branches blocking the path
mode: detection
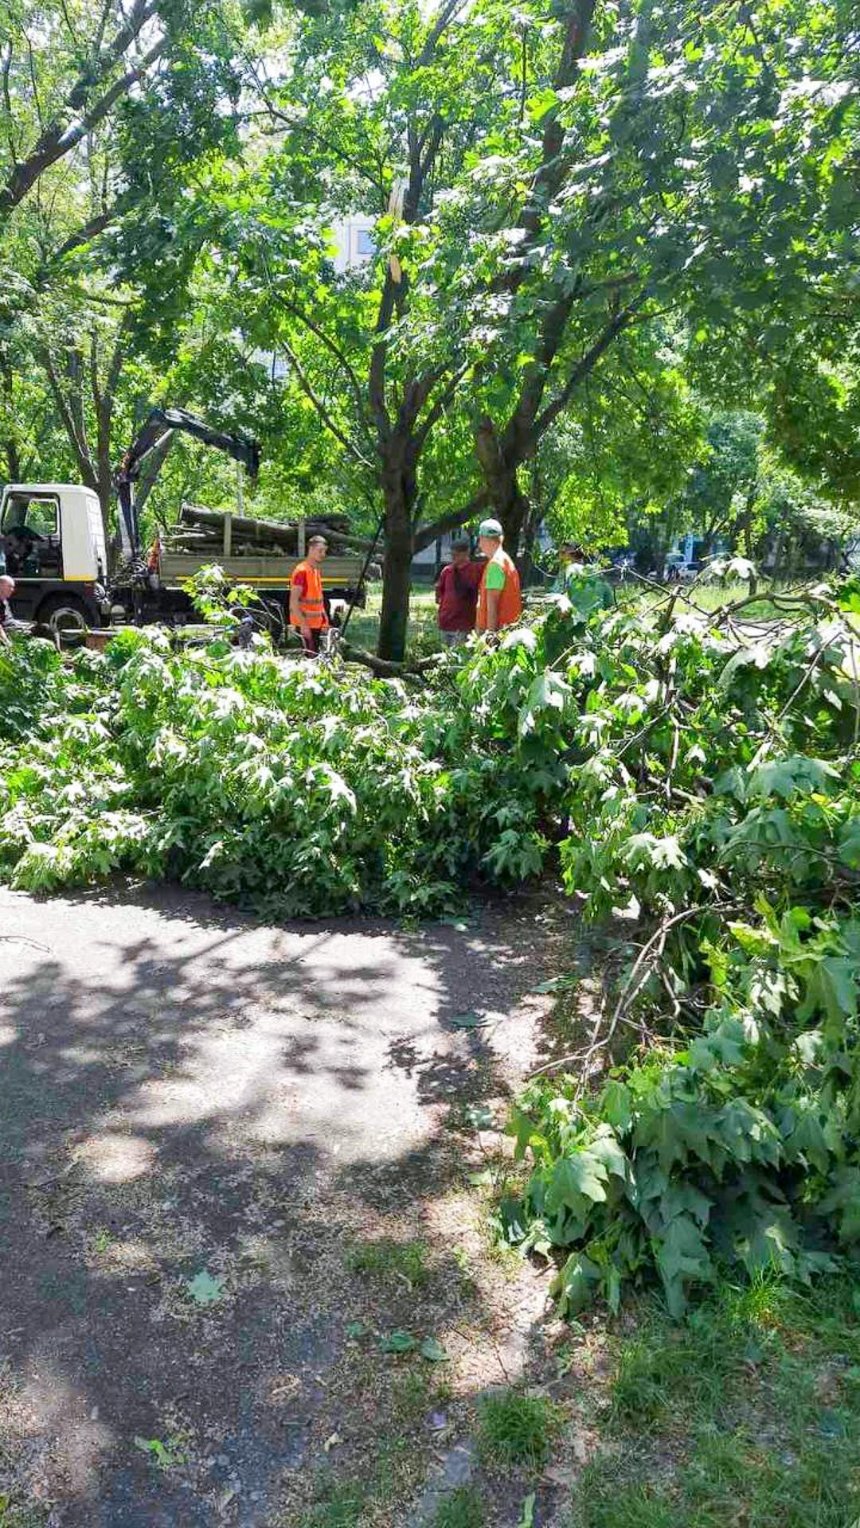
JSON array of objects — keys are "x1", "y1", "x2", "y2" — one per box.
[{"x1": 0, "y1": 585, "x2": 860, "y2": 1311}]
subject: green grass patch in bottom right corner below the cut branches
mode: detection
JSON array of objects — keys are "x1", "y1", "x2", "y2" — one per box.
[{"x1": 568, "y1": 1280, "x2": 860, "y2": 1528}]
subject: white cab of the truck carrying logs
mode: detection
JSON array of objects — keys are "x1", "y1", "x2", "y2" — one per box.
[{"x1": 0, "y1": 483, "x2": 110, "y2": 636}]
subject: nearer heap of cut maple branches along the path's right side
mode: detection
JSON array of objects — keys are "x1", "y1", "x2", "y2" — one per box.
[{"x1": 503, "y1": 591, "x2": 860, "y2": 1314}]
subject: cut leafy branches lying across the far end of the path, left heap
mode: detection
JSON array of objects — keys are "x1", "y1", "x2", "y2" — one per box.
[{"x1": 0, "y1": 630, "x2": 556, "y2": 915}]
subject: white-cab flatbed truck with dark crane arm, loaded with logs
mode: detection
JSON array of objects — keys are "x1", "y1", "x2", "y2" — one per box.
[{"x1": 0, "y1": 408, "x2": 367, "y2": 640}]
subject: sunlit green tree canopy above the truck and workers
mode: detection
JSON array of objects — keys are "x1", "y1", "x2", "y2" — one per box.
[{"x1": 0, "y1": 0, "x2": 860, "y2": 656}]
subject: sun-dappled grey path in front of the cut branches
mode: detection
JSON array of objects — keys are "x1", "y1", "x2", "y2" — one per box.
[{"x1": 0, "y1": 886, "x2": 583, "y2": 1528}]
